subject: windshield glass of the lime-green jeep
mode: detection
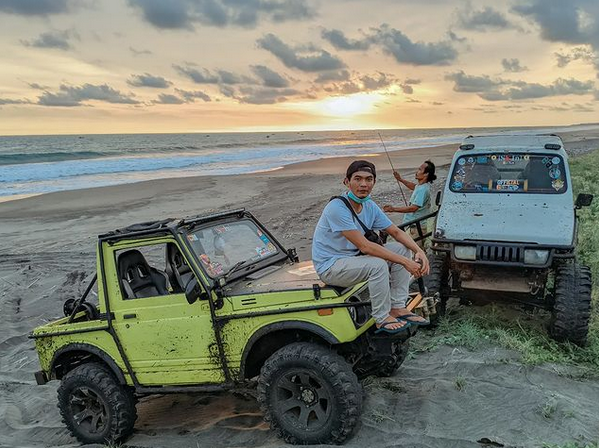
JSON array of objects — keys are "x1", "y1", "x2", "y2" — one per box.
[{"x1": 187, "y1": 220, "x2": 279, "y2": 278}]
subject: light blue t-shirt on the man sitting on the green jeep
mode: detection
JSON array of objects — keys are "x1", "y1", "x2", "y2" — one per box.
[{"x1": 312, "y1": 193, "x2": 393, "y2": 275}]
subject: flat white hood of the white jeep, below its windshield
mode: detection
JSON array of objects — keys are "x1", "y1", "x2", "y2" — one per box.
[{"x1": 435, "y1": 195, "x2": 575, "y2": 246}]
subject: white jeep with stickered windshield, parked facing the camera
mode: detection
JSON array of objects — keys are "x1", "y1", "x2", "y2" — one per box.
[{"x1": 427, "y1": 135, "x2": 593, "y2": 345}]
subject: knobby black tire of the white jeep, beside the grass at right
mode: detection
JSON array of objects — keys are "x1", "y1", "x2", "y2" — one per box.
[{"x1": 549, "y1": 260, "x2": 592, "y2": 346}]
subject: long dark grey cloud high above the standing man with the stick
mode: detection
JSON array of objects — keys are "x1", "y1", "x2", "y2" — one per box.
[{"x1": 374, "y1": 25, "x2": 458, "y2": 65}]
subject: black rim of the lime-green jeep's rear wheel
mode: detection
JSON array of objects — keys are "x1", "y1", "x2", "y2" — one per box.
[{"x1": 69, "y1": 386, "x2": 108, "y2": 437}]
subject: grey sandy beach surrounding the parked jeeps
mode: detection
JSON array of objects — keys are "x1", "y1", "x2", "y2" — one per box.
[{"x1": 0, "y1": 131, "x2": 599, "y2": 448}]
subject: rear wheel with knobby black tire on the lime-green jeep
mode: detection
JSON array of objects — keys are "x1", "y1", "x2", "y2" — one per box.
[{"x1": 58, "y1": 363, "x2": 137, "y2": 444}]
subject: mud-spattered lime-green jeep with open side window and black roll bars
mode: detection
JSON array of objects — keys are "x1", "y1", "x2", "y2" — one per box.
[{"x1": 31, "y1": 209, "x2": 414, "y2": 444}]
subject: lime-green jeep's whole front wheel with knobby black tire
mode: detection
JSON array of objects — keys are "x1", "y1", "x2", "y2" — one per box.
[{"x1": 258, "y1": 342, "x2": 362, "y2": 445}]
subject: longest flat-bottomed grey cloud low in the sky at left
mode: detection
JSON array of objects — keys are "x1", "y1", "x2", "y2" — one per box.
[{"x1": 37, "y1": 84, "x2": 139, "y2": 107}]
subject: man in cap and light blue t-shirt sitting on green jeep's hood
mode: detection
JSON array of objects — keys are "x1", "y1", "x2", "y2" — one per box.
[{"x1": 312, "y1": 160, "x2": 429, "y2": 333}]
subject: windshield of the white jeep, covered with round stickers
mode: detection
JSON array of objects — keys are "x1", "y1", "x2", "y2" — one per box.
[{"x1": 449, "y1": 153, "x2": 568, "y2": 194}]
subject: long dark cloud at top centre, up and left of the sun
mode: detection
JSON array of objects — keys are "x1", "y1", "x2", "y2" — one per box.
[{"x1": 257, "y1": 34, "x2": 345, "y2": 72}]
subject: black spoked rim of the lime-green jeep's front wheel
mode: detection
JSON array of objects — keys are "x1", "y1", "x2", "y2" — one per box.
[{"x1": 273, "y1": 369, "x2": 333, "y2": 431}]
